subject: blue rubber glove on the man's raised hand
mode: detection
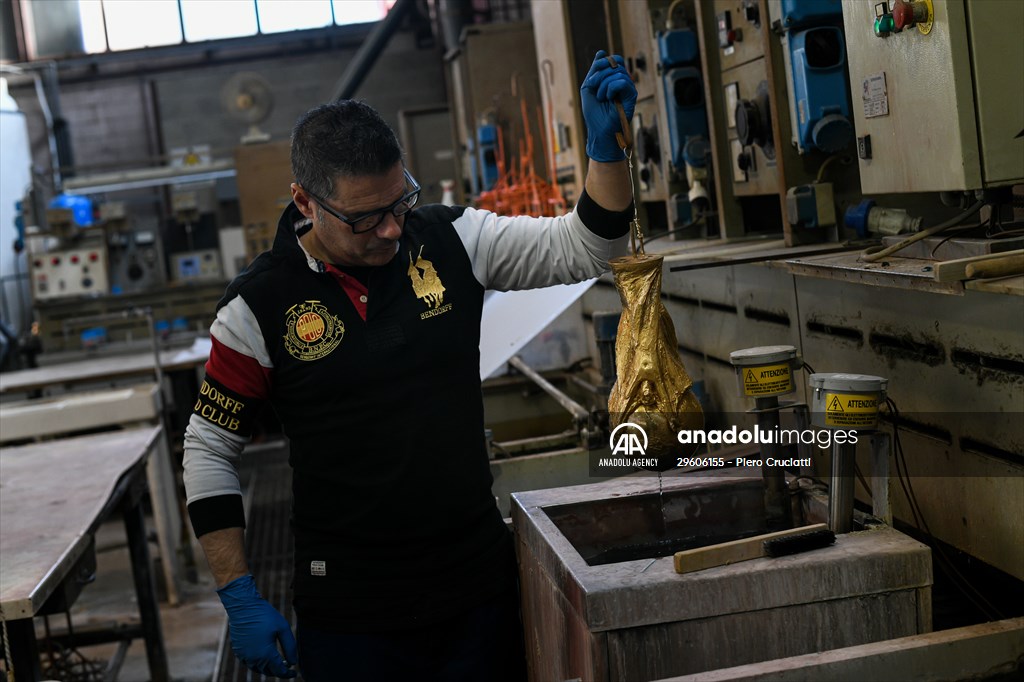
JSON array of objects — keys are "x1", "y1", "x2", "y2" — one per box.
[{"x1": 580, "y1": 50, "x2": 637, "y2": 162}]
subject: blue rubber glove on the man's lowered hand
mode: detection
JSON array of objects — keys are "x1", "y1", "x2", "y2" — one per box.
[{"x1": 217, "y1": 574, "x2": 299, "y2": 678}]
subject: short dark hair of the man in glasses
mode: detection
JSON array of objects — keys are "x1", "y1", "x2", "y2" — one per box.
[{"x1": 292, "y1": 99, "x2": 401, "y2": 199}]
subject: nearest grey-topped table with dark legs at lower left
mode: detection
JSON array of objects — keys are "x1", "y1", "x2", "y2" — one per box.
[{"x1": 0, "y1": 426, "x2": 169, "y2": 682}]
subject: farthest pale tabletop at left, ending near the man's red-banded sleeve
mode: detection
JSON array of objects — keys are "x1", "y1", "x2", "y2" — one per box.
[{"x1": 0, "y1": 337, "x2": 210, "y2": 393}]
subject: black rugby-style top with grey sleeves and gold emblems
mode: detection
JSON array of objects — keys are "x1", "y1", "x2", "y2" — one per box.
[{"x1": 184, "y1": 189, "x2": 632, "y2": 631}]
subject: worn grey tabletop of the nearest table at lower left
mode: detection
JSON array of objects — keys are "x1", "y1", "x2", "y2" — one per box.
[{"x1": 0, "y1": 426, "x2": 161, "y2": 620}]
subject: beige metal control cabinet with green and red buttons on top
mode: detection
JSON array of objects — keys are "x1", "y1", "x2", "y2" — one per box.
[{"x1": 843, "y1": 0, "x2": 1024, "y2": 195}]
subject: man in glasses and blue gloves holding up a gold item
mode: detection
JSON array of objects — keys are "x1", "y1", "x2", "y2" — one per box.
[{"x1": 184, "y1": 52, "x2": 636, "y2": 682}]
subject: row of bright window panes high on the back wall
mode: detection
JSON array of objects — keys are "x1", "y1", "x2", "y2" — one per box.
[{"x1": 78, "y1": 0, "x2": 394, "y2": 53}]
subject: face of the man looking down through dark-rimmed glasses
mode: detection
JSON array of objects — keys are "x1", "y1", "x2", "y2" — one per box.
[{"x1": 293, "y1": 163, "x2": 406, "y2": 266}]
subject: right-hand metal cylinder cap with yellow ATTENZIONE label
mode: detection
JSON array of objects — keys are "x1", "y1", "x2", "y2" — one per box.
[{"x1": 810, "y1": 373, "x2": 889, "y2": 430}]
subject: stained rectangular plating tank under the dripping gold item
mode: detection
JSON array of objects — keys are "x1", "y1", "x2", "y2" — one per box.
[{"x1": 512, "y1": 469, "x2": 932, "y2": 682}]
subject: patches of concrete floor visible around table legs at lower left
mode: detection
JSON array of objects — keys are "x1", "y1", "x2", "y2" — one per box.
[{"x1": 57, "y1": 519, "x2": 226, "y2": 682}]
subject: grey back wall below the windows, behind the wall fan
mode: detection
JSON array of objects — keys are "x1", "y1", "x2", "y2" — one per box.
[{"x1": 11, "y1": 26, "x2": 445, "y2": 184}]
